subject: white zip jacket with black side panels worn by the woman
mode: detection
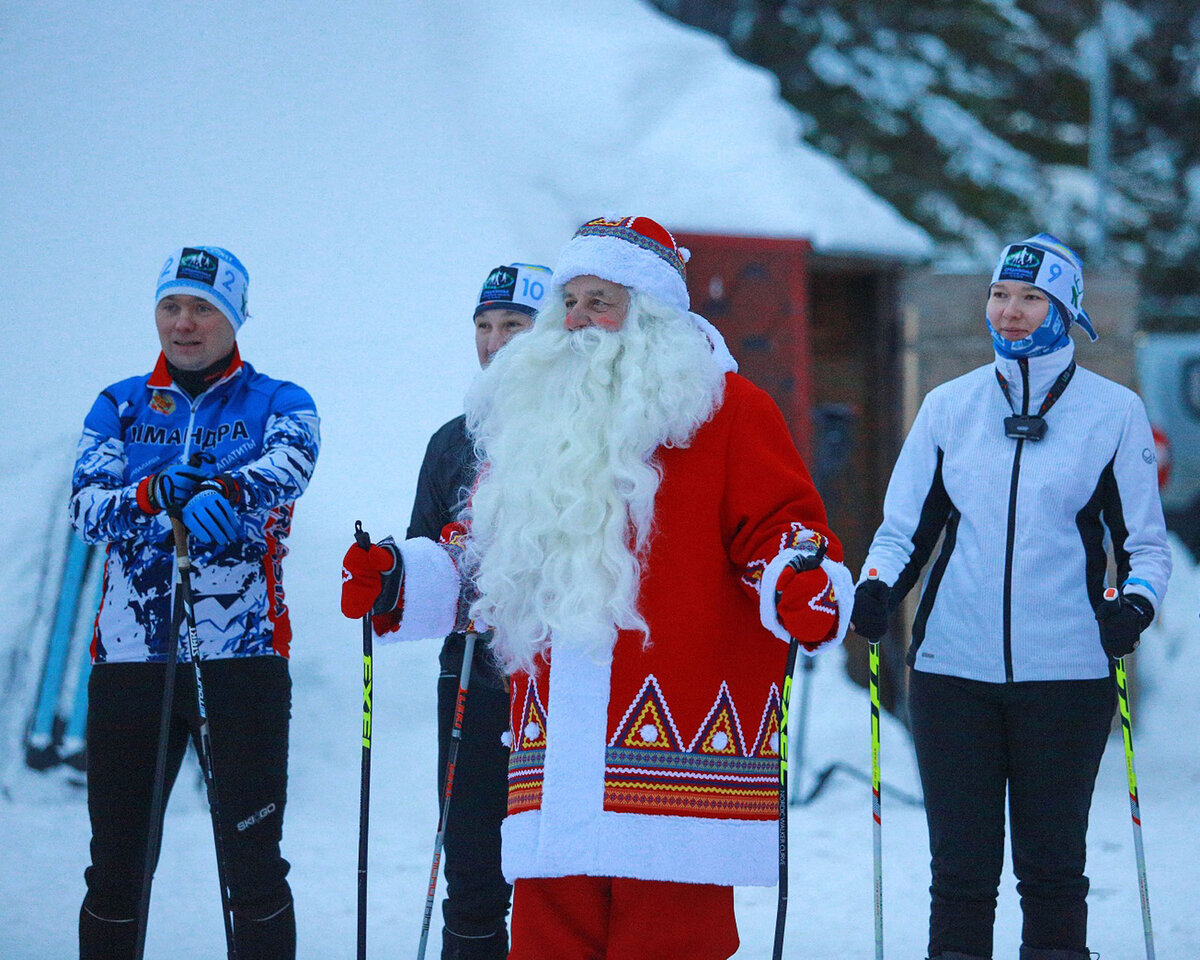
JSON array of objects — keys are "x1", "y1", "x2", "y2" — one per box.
[{"x1": 863, "y1": 343, "x2": 1171, "y2": 683}]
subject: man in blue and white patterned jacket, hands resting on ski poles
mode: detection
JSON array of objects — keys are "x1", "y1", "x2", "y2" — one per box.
[{"x1": 71, "y1": 247, "x2": 319, "y2": 960}]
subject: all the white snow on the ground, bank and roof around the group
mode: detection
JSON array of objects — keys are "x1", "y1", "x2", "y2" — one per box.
[{"x1": 0, "y1": 0, "x2": 1200, "y2": 960}]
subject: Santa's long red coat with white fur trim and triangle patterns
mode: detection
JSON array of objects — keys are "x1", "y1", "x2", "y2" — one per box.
[{"x1": 386, "y1": 373, "x2": 853, "y2": 886}]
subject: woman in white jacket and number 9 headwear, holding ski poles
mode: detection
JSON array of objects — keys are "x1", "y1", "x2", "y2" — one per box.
[{"x1": 853, "y1": 234, "x2": 1171, "y2": 960}]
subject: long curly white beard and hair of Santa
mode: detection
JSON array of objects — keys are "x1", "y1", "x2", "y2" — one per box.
[{"x1": 467, "y1": 293, "x2": 725, "y2": 672}]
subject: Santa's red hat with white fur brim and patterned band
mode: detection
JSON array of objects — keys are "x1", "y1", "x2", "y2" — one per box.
[{"x1": 554, "y1": 217, "x2": 691, "y2": 313}]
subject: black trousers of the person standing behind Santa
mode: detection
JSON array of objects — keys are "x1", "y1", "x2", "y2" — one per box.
[{"x1": 438, "y1": 634, "x2": 512, "y2": 960}]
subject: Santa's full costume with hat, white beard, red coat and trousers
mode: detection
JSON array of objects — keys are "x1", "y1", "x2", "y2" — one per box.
[{"x1": 352, "y1": 217, "x2": 853, "y2": 960}]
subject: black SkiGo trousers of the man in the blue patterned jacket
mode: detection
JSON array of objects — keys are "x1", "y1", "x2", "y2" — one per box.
[{"x1": 79, "y1": 656, "x2": 295, "y2": 960}]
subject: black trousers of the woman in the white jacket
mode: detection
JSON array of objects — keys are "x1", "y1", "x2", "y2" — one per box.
[{"x1": 908, "y1": 670, "x2": 1116, "y2": 958}]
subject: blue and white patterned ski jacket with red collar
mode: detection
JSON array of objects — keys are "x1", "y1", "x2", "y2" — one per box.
[{"x1": 71, "y1": 352, "x2": 320, "y2": 664}]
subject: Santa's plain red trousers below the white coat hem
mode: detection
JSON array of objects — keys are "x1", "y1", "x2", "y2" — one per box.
[{"x1": 509, "y1": 876, "x2": 738, "y2": 960}]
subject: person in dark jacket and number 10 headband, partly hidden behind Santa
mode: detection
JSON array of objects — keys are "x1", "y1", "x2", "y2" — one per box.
[{"x1": 408, "y1": 263, "x2": 551, "y2": 960}]
